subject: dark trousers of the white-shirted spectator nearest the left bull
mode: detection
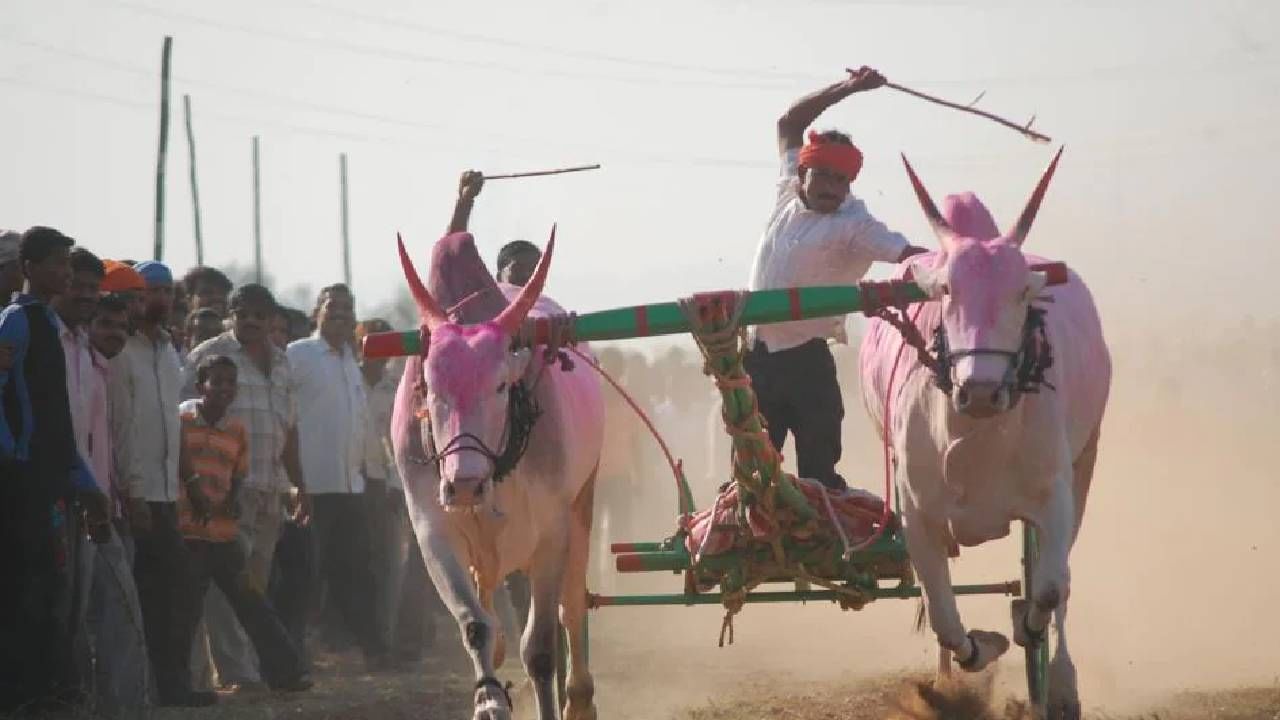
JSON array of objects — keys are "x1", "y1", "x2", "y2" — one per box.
[{"x1": 311, "y1": 493, "x2": 387, "y2": 657}]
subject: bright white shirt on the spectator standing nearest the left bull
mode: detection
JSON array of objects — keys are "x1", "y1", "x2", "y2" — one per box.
[{"x1": 288, "y1": 333, "x2": 369, "y2": 495}]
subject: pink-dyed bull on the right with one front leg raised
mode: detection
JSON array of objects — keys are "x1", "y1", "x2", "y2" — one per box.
[{"x1": 860, "y1": 151, "x2": 1111, "y2": 717}]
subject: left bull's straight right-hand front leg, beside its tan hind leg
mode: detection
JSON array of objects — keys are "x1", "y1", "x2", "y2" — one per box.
[{"x1": 521, "y1": 516, "x2": 570, "y2": 720}]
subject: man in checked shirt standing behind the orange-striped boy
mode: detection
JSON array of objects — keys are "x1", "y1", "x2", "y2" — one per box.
[{"x1": 183, "y1": 284, "x2": 311, "y2": 684}]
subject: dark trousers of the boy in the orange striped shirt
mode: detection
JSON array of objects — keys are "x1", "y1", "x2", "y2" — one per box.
[{"x1": 183, "y1": 539, "x2": 303, "y2": 687}]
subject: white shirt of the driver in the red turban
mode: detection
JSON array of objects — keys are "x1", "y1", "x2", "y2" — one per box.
[{"x1": 750, "y1": 150, "x2": 908, "y2": 352}]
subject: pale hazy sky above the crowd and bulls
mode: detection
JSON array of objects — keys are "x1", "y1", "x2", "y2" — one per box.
[{"x1": 0, "y1": 0, "x2": 1280, "y2": 330}]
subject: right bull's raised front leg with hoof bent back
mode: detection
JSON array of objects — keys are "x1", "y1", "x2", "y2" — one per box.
[{"x1": 902, "y1": 493, "x2": 1009, "y2": 673}]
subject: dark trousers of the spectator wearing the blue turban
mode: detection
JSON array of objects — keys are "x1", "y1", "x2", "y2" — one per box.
[{"x1": 133, "y1": 502, "x2": 205, "y2": 702}]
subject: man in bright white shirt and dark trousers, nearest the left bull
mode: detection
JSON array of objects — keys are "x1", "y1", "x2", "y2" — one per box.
[{"x1": 288, "y1": 284, "x2": 389, "y2": 670}]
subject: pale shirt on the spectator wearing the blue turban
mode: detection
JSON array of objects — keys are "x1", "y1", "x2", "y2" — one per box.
[{"x1": 109, "y1": 332, "x2": 182, "y2": 502}]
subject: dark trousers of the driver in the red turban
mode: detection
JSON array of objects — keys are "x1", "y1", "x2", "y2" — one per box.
[{"x1": 744, "y1": 340, "x2": 846, "y2": 489}]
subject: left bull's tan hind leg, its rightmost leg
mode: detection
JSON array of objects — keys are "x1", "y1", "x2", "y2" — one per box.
[{"x1": 561, "y1": 473, "x2": 595, "y2": 720}]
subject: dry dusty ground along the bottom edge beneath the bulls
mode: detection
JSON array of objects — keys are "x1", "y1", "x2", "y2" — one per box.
[{"x1": 156, "y1": 657, "x2": 1280, "y2": 720}]
